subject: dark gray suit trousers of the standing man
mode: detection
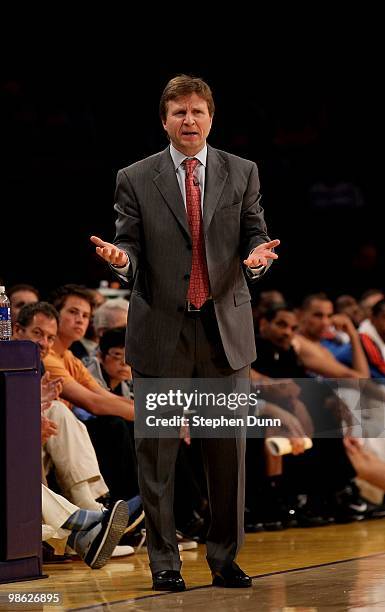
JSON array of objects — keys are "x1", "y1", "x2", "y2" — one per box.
[{"x1": 133, "y1": 300, "x2": 249, "y2": 573}]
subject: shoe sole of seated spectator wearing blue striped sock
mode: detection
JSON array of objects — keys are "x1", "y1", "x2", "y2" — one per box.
[{"x1": 84, "y1": 501, "x2": 128, "y2": 569}]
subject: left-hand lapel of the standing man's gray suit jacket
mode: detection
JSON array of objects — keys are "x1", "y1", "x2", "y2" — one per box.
[{"x1": 154, "y1": 147, "x2": 191, "y2": 240}]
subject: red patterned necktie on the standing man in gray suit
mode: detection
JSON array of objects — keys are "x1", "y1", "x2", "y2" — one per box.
[{"x1": 183, "y1": 159, "x2": 210, "y2": 308}]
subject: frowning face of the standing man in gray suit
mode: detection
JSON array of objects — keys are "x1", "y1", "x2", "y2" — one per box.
[{"x1": 163, "y1": 93, "x2": 213, "y2": 157}]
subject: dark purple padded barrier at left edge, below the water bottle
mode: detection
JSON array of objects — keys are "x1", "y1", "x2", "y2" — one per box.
[{"x1": 0, "y1": 341, "x2": 42, "y2": 583}]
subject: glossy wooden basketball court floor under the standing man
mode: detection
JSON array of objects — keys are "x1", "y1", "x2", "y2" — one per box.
[{"x1": 0, "y1": 519, "x2": 385, "y2": 612}]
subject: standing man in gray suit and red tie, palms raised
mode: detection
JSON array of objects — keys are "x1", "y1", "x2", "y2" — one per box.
[{"x1": 91, "y1": 75, "x2": 279, "y2": 591}]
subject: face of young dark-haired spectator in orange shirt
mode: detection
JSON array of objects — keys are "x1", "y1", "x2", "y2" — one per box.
[{"x1": 59, "y1": 295, "x2": 91, "y2": 343}]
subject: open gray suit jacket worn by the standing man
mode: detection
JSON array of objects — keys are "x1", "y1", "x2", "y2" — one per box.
[{"x1": 114, "y1": 146, "x2": 269, "y2": 376}]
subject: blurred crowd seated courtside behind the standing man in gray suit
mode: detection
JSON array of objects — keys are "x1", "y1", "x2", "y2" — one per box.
[{"x1": 2, "y1": 284, "x2": 385, "y2": 568}]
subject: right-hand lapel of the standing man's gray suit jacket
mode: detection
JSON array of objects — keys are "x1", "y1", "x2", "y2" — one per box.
[{"x1": 203, "y1": 145, "x2": 229, "y2": 233}]
